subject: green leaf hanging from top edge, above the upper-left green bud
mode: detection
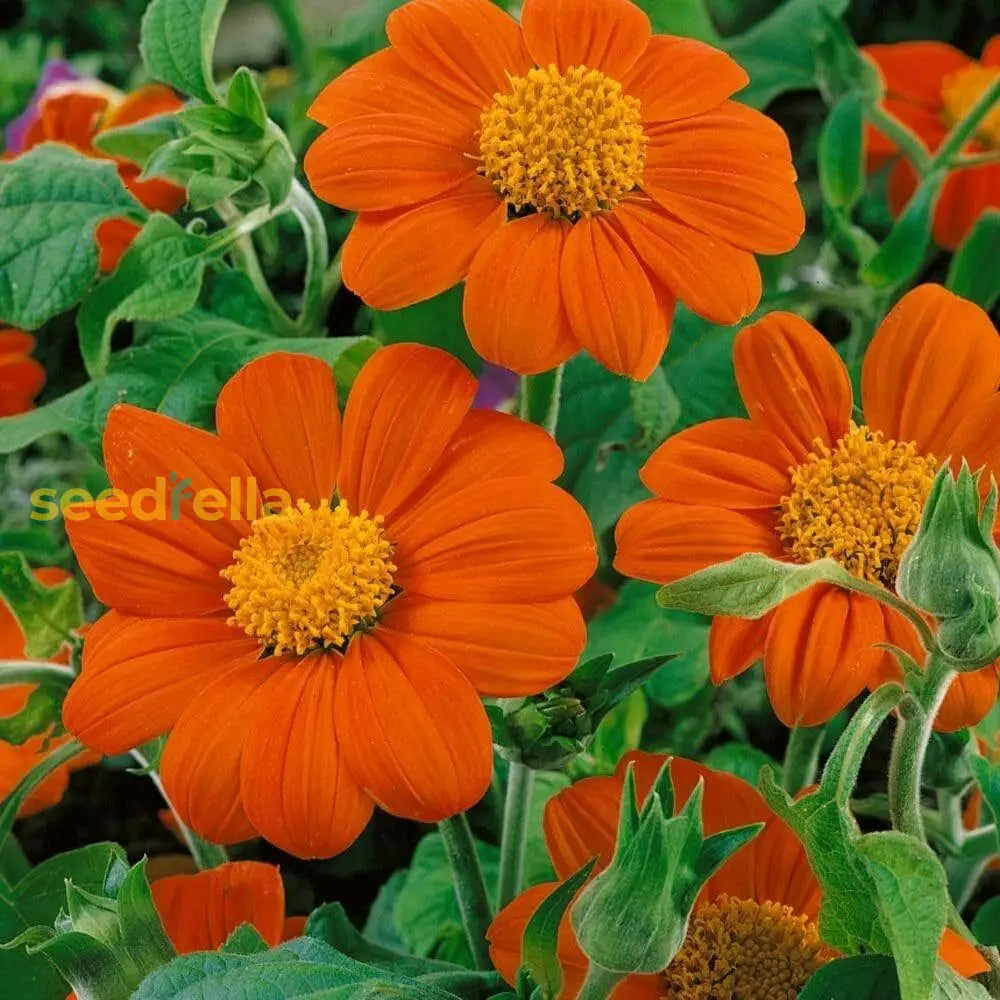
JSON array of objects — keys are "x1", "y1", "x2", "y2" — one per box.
[{"x1": 139, "y1": 0, "x2": 227, "y2": 104}]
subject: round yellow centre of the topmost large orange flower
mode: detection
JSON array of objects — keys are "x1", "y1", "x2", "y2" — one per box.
[{"x1": 479, "y1": 66, "x2": 647, "y2": 219}]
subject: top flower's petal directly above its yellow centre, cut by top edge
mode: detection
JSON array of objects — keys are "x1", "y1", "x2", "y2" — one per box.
[{"x1": 521, "y1": 0, "x2": 650, "y2": 80}]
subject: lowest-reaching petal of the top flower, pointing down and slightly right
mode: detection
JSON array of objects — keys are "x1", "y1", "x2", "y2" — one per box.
[{"x1": 559, "y1": 216, "x2": 668, "y2": 381}]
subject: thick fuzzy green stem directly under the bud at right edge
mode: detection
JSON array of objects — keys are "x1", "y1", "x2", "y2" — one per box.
[{"x1": 889, "y1": 654, "x2": 955, "y2": 840}]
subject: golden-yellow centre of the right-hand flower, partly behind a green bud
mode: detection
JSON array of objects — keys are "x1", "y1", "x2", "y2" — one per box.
[{"x1": 780, "y1": 424, "x2": 938, "y2": 587}]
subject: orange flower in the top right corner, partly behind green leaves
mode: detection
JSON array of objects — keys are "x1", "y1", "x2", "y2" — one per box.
[{"x1": 864, "y1": 35, "x2": 1000, "y2": 250}]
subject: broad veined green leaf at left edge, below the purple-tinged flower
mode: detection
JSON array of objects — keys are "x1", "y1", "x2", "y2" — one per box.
[{"x1": 0, "y1": 143, "x2": 142, "y2": 330}]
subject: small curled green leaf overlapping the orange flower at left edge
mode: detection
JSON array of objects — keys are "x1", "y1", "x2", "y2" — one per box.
[{"x1": 0, "y1": 552, "x2": 83, "y2": 660}]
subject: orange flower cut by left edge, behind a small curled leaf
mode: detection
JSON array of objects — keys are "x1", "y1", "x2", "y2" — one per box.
[{"x1": 0, "y1": 566, "x2": 88, "y2": 816}]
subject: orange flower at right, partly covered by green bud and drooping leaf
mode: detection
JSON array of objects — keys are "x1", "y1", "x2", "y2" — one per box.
[{"x1": 615, "y1": 285, "x2": 1000, "y2": 729}]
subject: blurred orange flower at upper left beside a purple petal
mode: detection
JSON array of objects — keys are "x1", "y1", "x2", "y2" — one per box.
[{"x1": 16, "y1": 80, "x2": 186, "y2": 271}]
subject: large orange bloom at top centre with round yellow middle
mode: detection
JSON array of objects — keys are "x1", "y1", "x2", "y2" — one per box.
[{"x1": 305, "y1": 0, "x2": 804, "y2": 379}]
